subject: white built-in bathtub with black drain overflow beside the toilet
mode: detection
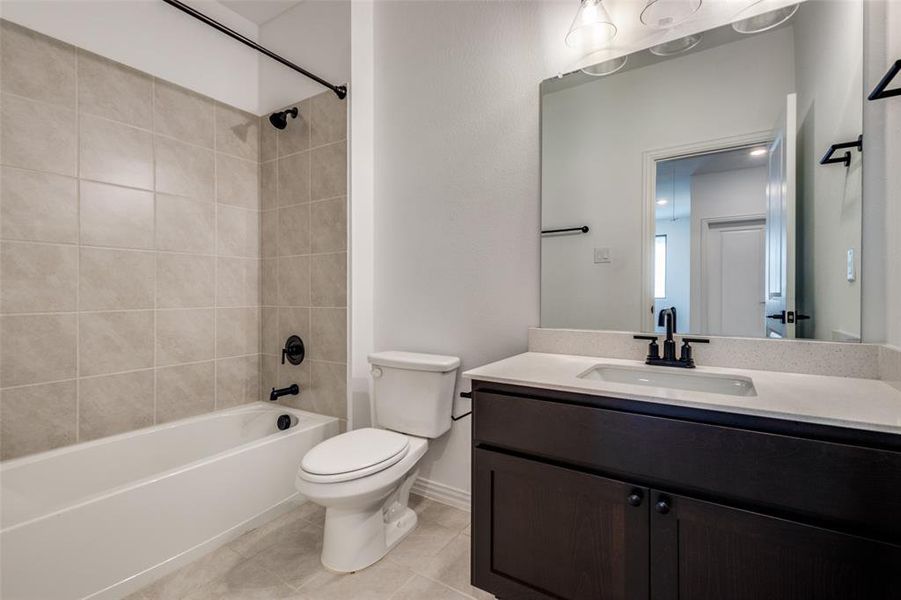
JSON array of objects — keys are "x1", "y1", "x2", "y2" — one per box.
[{"x1": 0, "y1": 402, "x2": 338, "y2": 600}]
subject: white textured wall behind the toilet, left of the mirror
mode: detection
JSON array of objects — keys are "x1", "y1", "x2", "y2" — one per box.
[{"x1": 375, "y1": 1, "x2": 559, "y2": 490}]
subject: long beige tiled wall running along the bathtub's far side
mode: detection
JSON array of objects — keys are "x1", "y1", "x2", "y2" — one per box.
[{"x1": 0, "y1": 22, "x2": 260, "y2": 458}]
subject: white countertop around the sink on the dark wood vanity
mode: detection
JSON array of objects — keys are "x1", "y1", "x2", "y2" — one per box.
[{"x1": 463, "y1": 352, "x2": 901, "y2": 435}]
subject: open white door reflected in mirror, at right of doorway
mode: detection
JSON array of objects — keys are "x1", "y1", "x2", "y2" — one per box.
[{"x1": 766, "y1": 94, "x2": 798, "y2": 338}]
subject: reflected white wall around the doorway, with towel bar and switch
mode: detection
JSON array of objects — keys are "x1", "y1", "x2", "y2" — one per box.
[{"x1": 541, "y1": 28, "x2": 794, "y2": 330}]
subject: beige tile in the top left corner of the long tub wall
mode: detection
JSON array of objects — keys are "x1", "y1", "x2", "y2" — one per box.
[{"x1": 0, "y1": 21, "x2": 75, "y2": 108}]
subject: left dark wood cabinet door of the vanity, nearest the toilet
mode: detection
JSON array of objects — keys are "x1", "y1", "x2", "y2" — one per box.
[{"x1": 472, "y1": 448, "x2": 649, "y2": 600}]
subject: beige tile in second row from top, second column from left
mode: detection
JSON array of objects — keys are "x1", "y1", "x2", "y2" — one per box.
[{"x1": 78, "y1": 115, "x2": 153, "y2": 190}]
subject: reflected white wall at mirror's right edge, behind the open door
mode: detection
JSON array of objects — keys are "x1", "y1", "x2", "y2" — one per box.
[{"x1": 795, "y1": 2, "x2": 864, "y2": 340}]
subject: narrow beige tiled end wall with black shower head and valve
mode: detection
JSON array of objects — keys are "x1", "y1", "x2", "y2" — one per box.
[{"x1": 260, "y1": 92, "x2": 347, "y2": 419}]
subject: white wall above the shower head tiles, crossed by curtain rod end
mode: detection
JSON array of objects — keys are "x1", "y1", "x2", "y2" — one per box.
[{"x1": 259, "y1": 0, "x2": 351, "y2": 114}]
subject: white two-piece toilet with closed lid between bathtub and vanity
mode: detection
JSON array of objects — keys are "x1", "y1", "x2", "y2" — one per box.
[{"x1": 295, "y1": 351, "x2": 460, "y2": 573}]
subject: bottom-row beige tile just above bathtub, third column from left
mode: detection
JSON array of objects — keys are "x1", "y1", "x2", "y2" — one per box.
[{"x1": 156, "y1": 361, "x2": 216, "y2": 423}]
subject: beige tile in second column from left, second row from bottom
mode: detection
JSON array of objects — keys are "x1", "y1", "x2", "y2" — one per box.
[{"x1": 78, "y1": 310, "x2": 153, "y2": 376}]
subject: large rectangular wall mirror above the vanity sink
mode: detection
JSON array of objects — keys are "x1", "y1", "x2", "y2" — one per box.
[{"x1": 541, "y1": 0, "x2": 865, "y2": 341}]
